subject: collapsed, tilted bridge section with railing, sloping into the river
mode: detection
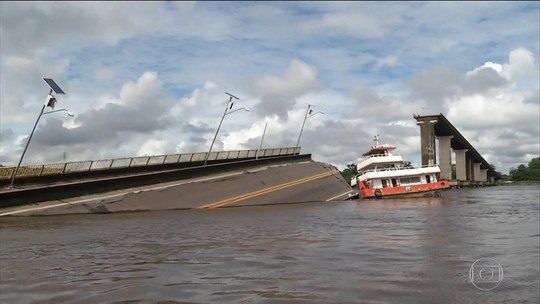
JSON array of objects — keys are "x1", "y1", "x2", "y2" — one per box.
[{"x1": 0, "y1": 147, "x2": 353, "y2": 217}]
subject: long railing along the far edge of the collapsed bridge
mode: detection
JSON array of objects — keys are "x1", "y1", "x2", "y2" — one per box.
[{"x1": 0, "y1": 147, "x2": 300, "y2": 180}]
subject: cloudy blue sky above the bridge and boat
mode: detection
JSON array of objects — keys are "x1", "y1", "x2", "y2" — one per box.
[{"x1": 0, "y1": 1, "x2": 540, "y2": 173}]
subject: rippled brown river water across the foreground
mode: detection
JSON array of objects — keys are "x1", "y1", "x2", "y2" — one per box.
[{"x1": 0, "y1": 185, "x2": 540, "y2": 303}]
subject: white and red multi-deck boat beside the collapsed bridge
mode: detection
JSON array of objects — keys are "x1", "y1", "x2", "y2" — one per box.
[{"x1": 351, "y1": 135, "x2": 450, "y2": 199}]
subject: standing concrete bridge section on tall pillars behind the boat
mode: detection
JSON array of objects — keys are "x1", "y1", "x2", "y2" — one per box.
[{"x1": 413, "y1": 114, "x2": 500, "y2": 187}]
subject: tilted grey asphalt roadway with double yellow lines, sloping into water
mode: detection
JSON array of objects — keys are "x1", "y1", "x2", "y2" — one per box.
[{"x1": 0, "y1": 161, "x2": 353, "y2": 216}]
